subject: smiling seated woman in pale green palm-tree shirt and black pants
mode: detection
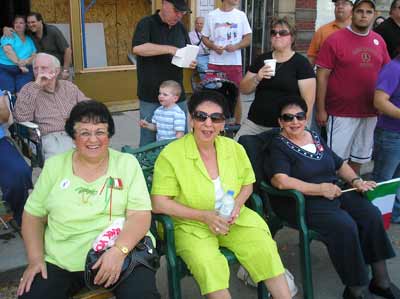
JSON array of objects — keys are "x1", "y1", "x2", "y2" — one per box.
[{"x1": 18, "y1": 101, "x2": 160, "y2": 299}]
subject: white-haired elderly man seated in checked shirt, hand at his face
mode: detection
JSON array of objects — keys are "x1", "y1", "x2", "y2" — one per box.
[{"x1": 14, "y1": 53, "x2": 87, "y2": 159}]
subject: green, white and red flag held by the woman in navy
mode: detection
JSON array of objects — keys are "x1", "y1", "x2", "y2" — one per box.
[{"x1": 366, "y1": 178, "x2": 400, "y2": 229}]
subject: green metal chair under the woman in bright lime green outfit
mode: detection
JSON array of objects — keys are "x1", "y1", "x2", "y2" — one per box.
[{"x1": 122, "y1": 141, "x2": 269, "y2": 299}]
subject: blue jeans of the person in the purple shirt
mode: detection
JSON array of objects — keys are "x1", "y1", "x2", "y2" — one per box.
[{"x1": 373, "y1": 128, "x2": 400, "y2": 223}]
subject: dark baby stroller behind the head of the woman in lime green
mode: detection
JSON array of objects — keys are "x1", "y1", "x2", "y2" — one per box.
[{"x1": 191, "y1": 70, "x2": 240, "y2": 137}]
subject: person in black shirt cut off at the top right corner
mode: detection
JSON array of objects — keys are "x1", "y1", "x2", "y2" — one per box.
[{"x1": 375, "y1": 0, "x2": 400, "y2": 59}]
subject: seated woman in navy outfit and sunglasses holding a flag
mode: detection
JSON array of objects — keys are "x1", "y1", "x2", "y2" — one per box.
[{"x1": 268, "y1": 97, "x2": 400, "y2": 299}]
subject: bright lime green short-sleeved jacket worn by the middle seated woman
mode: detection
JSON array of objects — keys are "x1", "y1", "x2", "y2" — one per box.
[{"x1": 151, "y1": 134, "x2": 265, "y2": 237}]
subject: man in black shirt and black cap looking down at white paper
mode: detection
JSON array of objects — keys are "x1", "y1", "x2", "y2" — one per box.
[{"x1": 132, "y1": 0, "x2": 196, "y2": 146}]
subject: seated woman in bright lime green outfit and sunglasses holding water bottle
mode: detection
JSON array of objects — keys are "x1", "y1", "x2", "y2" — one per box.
[{"x1": 151, "y1": 91, "x2": 291, "y2": 299}]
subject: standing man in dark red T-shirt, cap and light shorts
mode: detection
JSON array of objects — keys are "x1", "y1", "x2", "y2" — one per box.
[{"x1": 316, "y1": 0, "x2": 390, "y2": 177}]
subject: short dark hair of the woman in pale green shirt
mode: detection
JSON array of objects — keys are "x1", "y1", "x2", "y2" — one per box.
[{"x1": 64, "y1": 100, "x2": 115, "y2": 139}]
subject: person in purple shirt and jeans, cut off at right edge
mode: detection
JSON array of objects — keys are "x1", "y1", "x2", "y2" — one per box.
[{"x1": 373, "y1": 55, "x2": 400, "y2": 223}]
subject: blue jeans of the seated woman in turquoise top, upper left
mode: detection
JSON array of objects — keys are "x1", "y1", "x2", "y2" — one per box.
[{"x1": 0, "y1": 64, "x2": 33, "y2": 93}]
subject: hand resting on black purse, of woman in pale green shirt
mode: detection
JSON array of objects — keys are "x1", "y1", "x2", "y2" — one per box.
[{"x1": 92, "y1": 247, "x2": 125, "y2": 288}]
